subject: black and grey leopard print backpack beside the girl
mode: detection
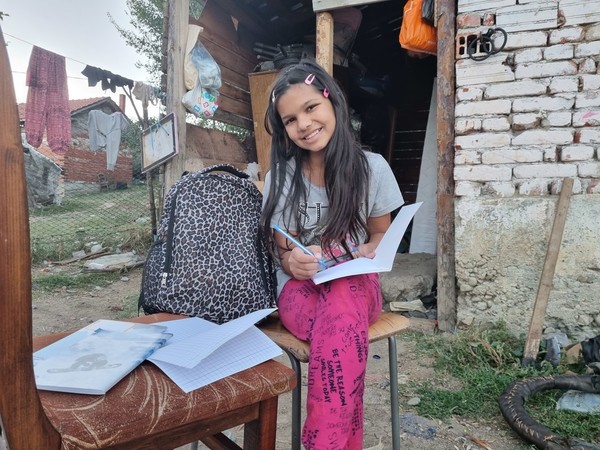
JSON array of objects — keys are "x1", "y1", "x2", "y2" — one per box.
[{"x1": 139, "y1": 164, "x2": 275, "y2": 324}]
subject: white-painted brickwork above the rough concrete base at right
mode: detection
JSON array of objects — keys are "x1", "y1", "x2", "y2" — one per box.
[{"x1": 454, "y1": 0, "x2": 600, "y2": 197}]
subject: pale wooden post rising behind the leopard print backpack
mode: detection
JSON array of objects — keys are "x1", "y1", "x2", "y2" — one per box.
[{"x1": 164, "y1": 0, "x2": 190, "y2": 193}]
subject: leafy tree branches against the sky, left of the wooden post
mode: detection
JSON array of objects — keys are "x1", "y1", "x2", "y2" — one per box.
[{"x1": 107, "y1": 0, "x2": 165, "y2": 85}]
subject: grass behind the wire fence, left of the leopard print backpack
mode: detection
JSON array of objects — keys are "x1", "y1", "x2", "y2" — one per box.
[{"x1": 29, "y1": 185, "x2": 152, "y2": 264}]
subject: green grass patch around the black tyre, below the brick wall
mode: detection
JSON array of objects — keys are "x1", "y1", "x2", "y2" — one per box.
[{"x1": 407, "y1": 323, "x2": 600, "y2": 449}]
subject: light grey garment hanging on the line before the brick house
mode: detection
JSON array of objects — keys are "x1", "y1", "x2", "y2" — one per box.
[{"x1": 88, "y1": 109, "x2": 129, "y2": 170}]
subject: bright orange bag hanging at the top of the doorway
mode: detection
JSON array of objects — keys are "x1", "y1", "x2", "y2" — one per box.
[{"x1": 399, "y1": 0, "x2": 437, "y2": 55}]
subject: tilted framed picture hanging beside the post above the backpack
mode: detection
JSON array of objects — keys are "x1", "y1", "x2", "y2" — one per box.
[{"x1": 142, "y1": 113, "x2": 179, "y2": 172}]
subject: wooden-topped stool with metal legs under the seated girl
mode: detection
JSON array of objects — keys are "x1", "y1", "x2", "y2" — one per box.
[{"x1": 259, "y1": 312, "x2": 410, "y2": 450}]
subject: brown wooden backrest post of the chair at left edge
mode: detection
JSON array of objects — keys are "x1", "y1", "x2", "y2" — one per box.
[{"x1": 0, "y1": 25, "x2": 60, "y2": 449}]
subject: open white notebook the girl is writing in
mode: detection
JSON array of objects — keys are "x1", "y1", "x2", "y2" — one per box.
[{"x1": 312, "y1": 202, "x2": 423, "y2": 284}]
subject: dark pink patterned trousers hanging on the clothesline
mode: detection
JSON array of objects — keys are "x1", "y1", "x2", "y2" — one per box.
[{"x1": 25, "y1": 46, "x2": 71, "y2": 154}]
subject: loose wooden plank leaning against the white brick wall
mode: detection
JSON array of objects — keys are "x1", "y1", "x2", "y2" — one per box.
[{"x1": 522, "y1": 178, "x2": 573, "y2": 367}]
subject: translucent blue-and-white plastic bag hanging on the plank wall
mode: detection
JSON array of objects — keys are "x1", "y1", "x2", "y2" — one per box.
[{"x1": 181, "y1": 41, "x2": 221, "y2": 118}]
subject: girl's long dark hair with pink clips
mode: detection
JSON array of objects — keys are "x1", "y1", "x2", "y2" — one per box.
[{"x1": 261, "y1": 59, "x2": 370, "y2": 258}]
